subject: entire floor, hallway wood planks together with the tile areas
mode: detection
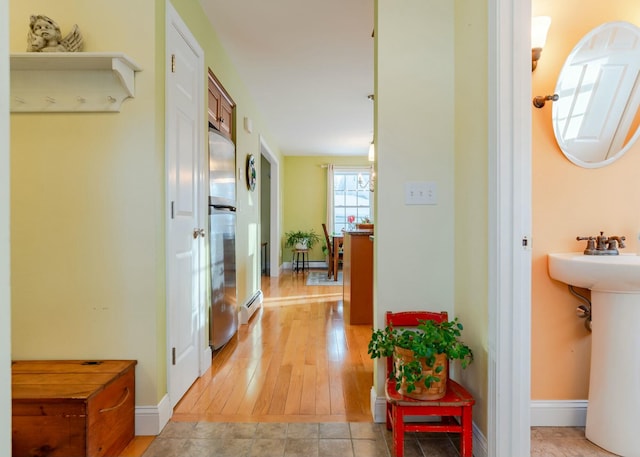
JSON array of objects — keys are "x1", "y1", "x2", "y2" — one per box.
[{"x1": 121, "y1": 272, "x2": 613, "y2": 457}]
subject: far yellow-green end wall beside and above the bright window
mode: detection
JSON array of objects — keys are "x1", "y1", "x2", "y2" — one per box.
[{"x1": 281, "y1": 156, "x2": 371, "y2": 262}]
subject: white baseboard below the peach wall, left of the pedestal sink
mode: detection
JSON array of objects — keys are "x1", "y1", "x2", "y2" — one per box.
[{"x1": 531, "y1": 400, "x2": 589, "y2": 427}]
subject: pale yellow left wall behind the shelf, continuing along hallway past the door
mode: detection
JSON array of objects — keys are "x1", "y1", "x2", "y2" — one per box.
[{"x1": 10, "y1": 0, "x2": 279, "y2": 405}]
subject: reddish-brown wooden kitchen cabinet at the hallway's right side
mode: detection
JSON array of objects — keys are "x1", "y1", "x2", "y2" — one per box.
[{"x1": 342, "y1": 230, "x2": 373, "y2": 324}]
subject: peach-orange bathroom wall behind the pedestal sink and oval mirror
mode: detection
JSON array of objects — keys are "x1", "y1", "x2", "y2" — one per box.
[{"x1": 531, "y1": 0, "x2": 640, "y2": 400}]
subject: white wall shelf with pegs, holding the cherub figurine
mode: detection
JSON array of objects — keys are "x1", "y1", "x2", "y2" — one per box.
[{"x1": 10, "y1": 52, "x2": 142, "y2": 113}]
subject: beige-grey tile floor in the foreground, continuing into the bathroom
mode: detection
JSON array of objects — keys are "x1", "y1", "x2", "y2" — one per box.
[{"x1": 143, "y1": 422, "x2": 614, "y2": 457}]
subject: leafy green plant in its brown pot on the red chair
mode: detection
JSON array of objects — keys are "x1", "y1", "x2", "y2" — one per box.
[{"x1": 368, "y1": 317, "x2": 473, "y2": 400}]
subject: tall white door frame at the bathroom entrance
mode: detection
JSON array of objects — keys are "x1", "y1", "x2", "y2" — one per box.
[{"x1": 487, "y1": 0, "x2": 532, "y2": 457}]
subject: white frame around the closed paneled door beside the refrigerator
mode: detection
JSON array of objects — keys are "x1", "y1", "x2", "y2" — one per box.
[{"x1": 164, "y1": 0, "x2": 212, "y2": 407}]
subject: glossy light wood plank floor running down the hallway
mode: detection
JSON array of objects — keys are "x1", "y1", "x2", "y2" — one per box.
[{"x1": 172, "y1": 271, "x2": 373, "y2": 422}]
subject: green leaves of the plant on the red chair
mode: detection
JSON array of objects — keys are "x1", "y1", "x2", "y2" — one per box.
[{"x1": 368, "y1": 317, "x2": 473, "y2": 392}]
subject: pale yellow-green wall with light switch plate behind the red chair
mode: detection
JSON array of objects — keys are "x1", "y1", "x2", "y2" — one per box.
[{"x1": 375, "y1": 0, "x2": 488, "y2": 435}]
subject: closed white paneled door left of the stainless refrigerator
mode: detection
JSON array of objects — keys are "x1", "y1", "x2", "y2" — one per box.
[{"x1": 166, "y1": 5, "x2": 205, "y2": 407}]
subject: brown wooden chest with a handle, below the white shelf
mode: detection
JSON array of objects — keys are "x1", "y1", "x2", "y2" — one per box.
[{"x1": 11, "y1": 360, "x2": 136, "y2": 457}]
